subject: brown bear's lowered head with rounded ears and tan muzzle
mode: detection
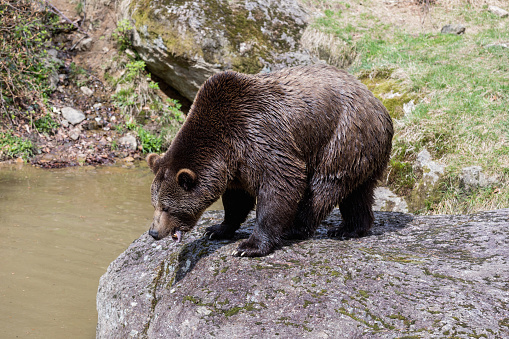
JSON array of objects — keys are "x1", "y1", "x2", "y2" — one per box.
[{"x1": 147, "y1": 154, "x2": 204, "y2": 242}]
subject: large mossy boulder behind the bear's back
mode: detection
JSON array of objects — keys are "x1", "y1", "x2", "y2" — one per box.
[{"x1": 118, "y1": 0, "x2": 312, "y2": 101}]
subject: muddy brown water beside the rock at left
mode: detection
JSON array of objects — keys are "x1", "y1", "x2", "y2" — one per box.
[{"x1": 0, "y1": 164, "x2": 221, "y2": 339}]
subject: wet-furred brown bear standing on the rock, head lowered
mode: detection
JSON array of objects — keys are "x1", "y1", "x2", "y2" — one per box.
[{"x1": 147, "y1": 64, "x2": 393, "y2": 257}]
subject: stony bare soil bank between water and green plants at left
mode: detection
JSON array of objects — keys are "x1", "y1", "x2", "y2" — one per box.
[{"x1": 3, "y1": 0, "x2": 142, "y2": 168}]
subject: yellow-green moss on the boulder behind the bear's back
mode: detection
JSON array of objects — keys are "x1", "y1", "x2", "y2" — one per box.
[{"x1": 130, "y1": 0, "x2": 304, "y2": 74}]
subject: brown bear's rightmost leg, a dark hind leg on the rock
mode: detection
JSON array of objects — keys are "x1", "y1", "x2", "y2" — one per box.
[{"x1": 327, "y1": 179, "x2": 376, "y2": 239}]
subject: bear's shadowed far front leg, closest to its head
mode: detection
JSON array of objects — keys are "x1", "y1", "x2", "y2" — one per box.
[{"x1": 205, "y1": 189, "x2": 256, "y2": 239}]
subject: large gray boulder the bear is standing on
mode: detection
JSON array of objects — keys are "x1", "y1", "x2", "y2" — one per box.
[{"x1": 97, "y1": 209, "x2": 509, "y2": 338}]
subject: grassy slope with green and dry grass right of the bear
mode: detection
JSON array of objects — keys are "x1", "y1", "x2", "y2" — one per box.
[{"x1": 309, "y1": 1, "x2": 509, "y2": 213}]
